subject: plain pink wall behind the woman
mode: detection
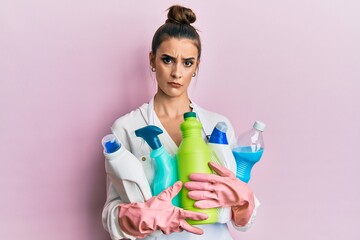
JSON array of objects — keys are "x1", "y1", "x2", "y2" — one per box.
[{"x1": 0, "y1": 0, "x2": 360, "y2": 240}]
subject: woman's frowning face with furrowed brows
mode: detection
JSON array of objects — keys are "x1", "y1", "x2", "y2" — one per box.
[{"x1": 150, "y1": 38, "x2": 199, "y2": 97}]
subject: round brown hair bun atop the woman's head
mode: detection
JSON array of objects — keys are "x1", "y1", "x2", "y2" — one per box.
[{"x1": 166, "y1": 5, "x2": 196, "y2": 25}]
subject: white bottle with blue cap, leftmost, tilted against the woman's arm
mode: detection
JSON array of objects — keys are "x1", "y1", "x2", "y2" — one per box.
[{"x1": 102, "y1": 134, "x2": 152, "y2": 203}]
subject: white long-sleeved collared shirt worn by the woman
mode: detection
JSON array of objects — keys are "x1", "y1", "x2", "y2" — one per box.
[{"x1": 102, "y1": 99, "x2": 259, "y2": 240}]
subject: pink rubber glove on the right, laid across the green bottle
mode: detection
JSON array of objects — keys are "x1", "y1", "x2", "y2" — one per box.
[{"x1": 185, "y1": 162, "x2": 255, "y2": 226}]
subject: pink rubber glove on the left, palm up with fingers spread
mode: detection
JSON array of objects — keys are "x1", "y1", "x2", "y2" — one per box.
[{"x1": 119, "y1": 181, "x2": 208, "y2": 238}]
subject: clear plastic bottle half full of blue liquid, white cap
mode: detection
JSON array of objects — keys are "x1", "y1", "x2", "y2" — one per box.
[{"x1": 232, "y1": 121, "x2": 266, "y2": 183}]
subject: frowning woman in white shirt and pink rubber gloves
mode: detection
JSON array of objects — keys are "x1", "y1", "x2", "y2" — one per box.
[{"x1": 103, "y1": 6, "x2": 258, "y2": 240}]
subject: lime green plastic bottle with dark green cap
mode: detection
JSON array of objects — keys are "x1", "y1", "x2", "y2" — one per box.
[{"x1": 176, "y1": 112, "x2": 217, "y2": 225}]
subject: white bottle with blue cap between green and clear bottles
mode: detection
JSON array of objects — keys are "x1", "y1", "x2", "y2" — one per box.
[{"x1": 208, "y1": 122, "x2": 236, "y2": 223}]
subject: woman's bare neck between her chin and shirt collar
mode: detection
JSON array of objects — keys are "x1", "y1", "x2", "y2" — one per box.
[{"x1": 154, "y1": 92, "x2": 191, "y2": 119}]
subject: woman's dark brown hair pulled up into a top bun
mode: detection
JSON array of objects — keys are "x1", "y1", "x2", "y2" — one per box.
[{"x1": 151, "y1": 5, "x2": 201, "y2": 60}]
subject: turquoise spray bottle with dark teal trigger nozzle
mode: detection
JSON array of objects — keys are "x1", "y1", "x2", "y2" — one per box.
[{"x1": 135, "y1": 125, "x2": 180, "y2": 207}]
